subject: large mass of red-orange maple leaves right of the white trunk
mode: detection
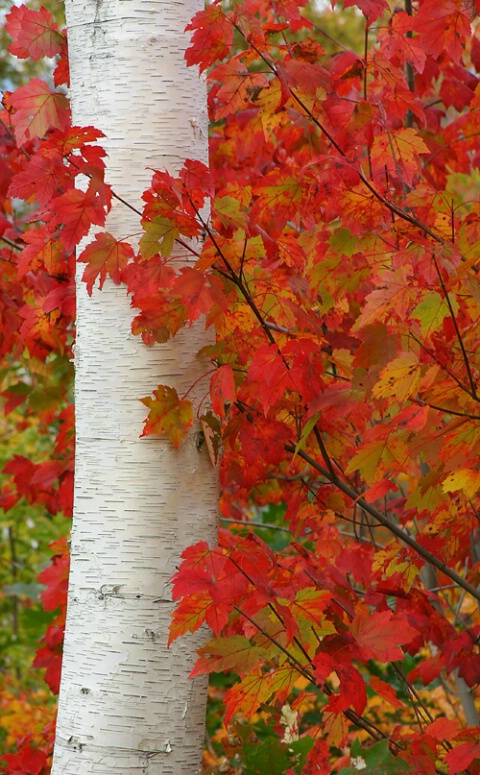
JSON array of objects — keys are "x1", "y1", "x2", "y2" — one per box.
[{"x1": 167, "y1": 0, "x2": 480, "y2": 773}]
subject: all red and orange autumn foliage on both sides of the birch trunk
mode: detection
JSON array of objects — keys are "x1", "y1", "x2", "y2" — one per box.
[{"x1": 0, "y1": 0, "x2": 480, "y2": 775}]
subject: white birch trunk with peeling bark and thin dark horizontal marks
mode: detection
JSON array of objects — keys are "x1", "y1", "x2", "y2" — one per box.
[{"x1": 53, "y1": 0, "x2": 217, "y2": 775}]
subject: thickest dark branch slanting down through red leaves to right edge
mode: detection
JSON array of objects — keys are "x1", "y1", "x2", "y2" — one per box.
[{"x1": 285, "y1": 444, "x2": 480, "y2": 602}]
